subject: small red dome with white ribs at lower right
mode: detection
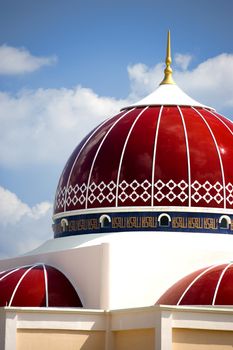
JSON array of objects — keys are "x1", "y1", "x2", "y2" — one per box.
[{"x1": 156, "y1": 263, "x2": 233, "y2": 305}]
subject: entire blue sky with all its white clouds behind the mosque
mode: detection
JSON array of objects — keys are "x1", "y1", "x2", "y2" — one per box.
[{"x1": 0, "y1": 0, "x2": 233, "y2": 256}]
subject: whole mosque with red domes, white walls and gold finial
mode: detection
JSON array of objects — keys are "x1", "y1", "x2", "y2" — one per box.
[{"x1": 0, "y1": 33, "x2": 233, "y2": 350}]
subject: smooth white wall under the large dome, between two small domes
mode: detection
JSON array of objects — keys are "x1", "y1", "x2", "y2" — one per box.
[{"x1": 0, "y1": 232, "x2": 233, "y2": 309}]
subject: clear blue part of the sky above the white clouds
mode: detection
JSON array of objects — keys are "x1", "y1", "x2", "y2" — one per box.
[{"x1": 0, "y1": 0, "x2": 233, "y2": 94}]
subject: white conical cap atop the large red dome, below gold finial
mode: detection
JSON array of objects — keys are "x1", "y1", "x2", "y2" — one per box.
[{"x1": 122, "y1": 84, "x2": 215, "y2": 111}]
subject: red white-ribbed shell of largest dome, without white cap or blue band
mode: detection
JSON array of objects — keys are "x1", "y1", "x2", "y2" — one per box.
[{"x1": 54, "y1": 102, "x2": 233, "y2": 218}]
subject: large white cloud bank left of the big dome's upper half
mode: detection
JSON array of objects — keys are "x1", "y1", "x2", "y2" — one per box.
[{"x1": 0, "y1": 86, "x2": 126, "y2": 167}]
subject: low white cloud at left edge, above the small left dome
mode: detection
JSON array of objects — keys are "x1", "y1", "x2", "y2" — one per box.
[{"x1": 0, "y1": 186, "x2": 52, "y2": 258}]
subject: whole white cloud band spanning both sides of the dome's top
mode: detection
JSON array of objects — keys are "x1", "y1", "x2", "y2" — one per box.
[{"x1": 0, "y1": 54, "x2": 233, "y2": 171}]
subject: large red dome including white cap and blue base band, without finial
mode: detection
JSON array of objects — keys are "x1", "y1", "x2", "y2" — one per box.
[{"x1": 53, "y1": 66, "x2": 233, "y2": 237}]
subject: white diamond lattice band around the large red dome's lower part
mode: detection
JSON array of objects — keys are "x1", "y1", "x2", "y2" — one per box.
[{"x1": 55, "y1": 179, "x2": 233, "y2": 210}]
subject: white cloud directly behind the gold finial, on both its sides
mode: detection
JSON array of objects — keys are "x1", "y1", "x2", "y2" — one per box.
[{"x1": 128, "y1": 54, "x2": 233, "y2": 112}]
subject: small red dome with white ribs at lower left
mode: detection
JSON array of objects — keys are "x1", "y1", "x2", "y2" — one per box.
[{"x1": 0, "y1": 264, "x2": 82, "y2": 307}]
